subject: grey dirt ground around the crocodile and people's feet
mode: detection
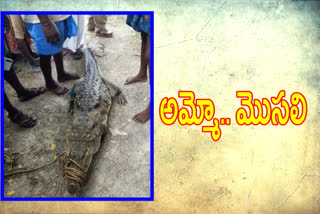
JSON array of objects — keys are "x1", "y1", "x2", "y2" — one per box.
[{"x1": 4, "y1": 16, "x2": 150, "y2": 197}]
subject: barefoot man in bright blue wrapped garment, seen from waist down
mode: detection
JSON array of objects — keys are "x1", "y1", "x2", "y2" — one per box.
[{"x1": 23, "y1": 15, "x2": 80, "y2": 95}]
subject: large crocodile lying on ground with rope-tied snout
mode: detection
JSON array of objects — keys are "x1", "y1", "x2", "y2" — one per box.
[{"x1": 61, "y1": 48, "x2": 127, "y2": 195}]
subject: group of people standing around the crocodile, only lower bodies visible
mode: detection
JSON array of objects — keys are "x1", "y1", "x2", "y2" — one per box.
[{"x1": 4, "y1": 15, "x2": 150, "y2": 127}]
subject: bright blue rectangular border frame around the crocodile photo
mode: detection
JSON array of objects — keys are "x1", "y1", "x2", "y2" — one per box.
[{"x1": 0, "y1": 11, "x2": 154, "y2": 201}]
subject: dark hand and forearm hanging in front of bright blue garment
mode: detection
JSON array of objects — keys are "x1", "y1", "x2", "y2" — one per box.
[{"x1": 38, "y1": 15, "x2": 61, "y2": 44}]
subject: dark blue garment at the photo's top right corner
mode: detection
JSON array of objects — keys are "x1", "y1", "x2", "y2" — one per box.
[{"x1": 127, "y1": 15, "x2": 150, "y2": 35}]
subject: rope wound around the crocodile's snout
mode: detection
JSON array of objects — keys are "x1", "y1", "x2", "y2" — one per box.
[{"x1": 60, "y1": 153, "x2": 87, "y2": 185}]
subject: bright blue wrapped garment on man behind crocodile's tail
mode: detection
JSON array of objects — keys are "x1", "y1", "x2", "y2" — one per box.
[{"x1": 25, "y1": 16, "x2": 78, "y2": 55}]
